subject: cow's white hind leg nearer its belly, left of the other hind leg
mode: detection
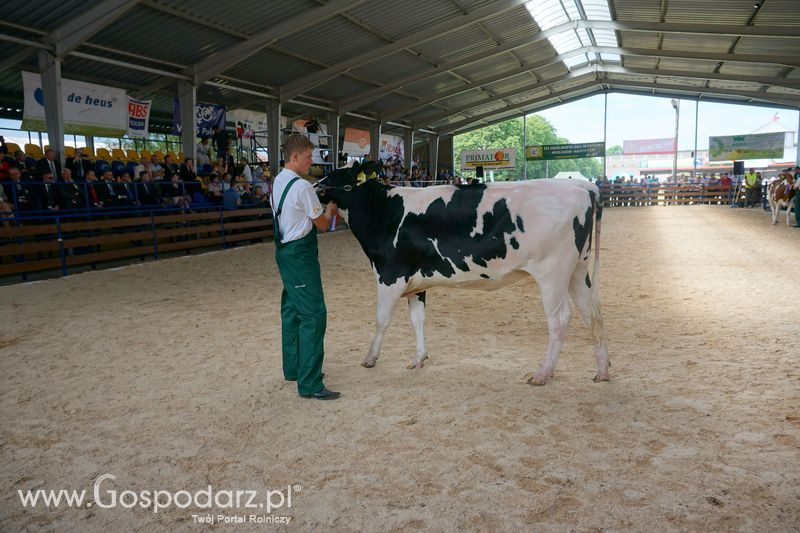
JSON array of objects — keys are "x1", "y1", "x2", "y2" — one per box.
[{"x1": 525, "y1": 266, "x2": 572, "y2": 385}]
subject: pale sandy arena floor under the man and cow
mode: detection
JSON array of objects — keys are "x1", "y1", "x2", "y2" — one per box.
[{"x1": 0, "y1": 206, "x2": 800, "y2": 532}]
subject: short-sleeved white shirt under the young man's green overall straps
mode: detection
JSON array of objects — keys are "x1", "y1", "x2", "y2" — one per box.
[{"x1": 270, "y1": 168, "x2": 323, "y2": 243}]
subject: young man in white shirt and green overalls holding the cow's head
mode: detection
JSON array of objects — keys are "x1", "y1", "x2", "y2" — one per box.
[{"x1": 270, "y1": 135, "x2": 340, "y2": 400}]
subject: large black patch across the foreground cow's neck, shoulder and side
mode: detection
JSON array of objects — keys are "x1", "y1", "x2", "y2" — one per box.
[{"x1": 333, "y1": 181, "x2": 519, "y2": 285}]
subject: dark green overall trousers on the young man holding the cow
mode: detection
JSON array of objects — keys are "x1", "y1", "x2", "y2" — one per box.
[{"x1": 275, "y1": 228, "x2": 327, "y2": 394}]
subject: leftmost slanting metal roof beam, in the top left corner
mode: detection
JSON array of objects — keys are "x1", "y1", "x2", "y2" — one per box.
[{"x1": 42, "y1": 0, "x2": 139, "y2": 59}]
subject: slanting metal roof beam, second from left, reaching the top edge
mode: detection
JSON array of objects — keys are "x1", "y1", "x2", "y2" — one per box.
[{"x1": 190, "y1": 0, "x2": 366, "y2": 85}]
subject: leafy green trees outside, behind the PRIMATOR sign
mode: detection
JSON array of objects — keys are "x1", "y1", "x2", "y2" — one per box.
[{"x1": 453, "y1": 115, "x2": 603, "y2": 181}]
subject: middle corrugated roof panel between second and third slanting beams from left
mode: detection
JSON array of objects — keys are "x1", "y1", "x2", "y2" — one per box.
[{"x1": 277, "y1": 17, "x2": 387, "y2": 65}]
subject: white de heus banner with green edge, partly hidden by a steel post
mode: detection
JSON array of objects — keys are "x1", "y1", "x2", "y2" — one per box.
[{"x1": 22, "y1": 72, "x2": 128, "y2": 136}]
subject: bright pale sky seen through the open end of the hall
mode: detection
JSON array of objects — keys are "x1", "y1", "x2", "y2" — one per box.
[{"x1": 536, "y1": 94, "x2": 798, "y2": 150}]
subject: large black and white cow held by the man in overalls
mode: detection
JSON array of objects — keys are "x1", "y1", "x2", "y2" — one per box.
[{"x1": 323, "y1": 163, "x2": 609, "y2": 385}]
